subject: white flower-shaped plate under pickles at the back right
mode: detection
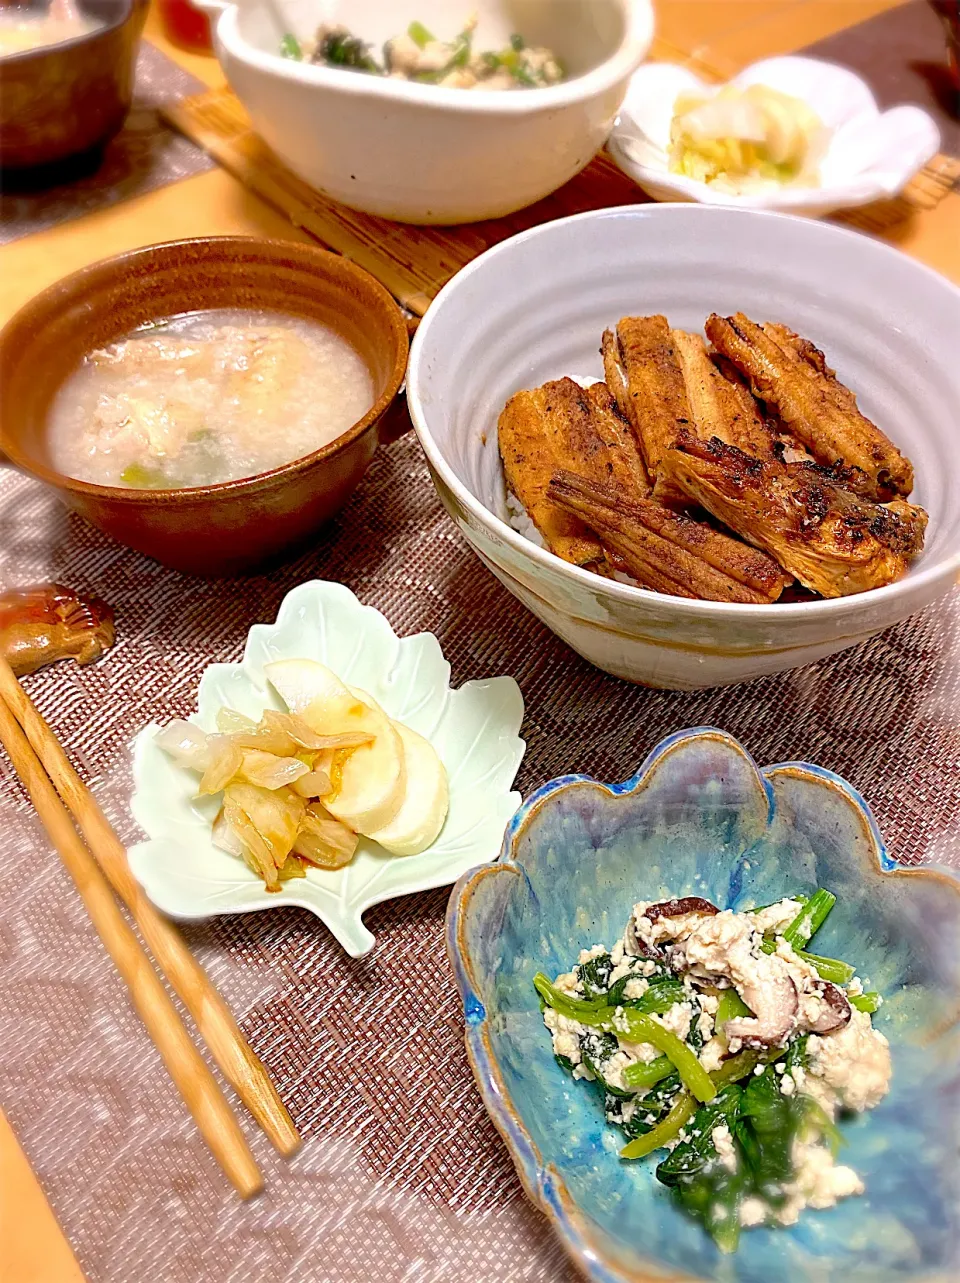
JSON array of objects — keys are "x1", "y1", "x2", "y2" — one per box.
[{"x1": 607, "y1": 58, "x2": 939, "y2": 217}]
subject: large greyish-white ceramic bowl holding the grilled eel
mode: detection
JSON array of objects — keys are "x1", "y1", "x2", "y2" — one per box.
[{"x1": 407, "y1": 205, "x2": 960, "y2": 690}]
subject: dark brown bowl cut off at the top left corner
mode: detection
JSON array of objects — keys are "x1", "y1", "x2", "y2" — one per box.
[{"x1": 0, "y1": 0, "x2": 148, "y2": 170}]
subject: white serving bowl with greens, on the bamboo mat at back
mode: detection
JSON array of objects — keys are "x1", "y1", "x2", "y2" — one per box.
[{"x1": 200, "y1": 0, "x2": 653, "y2": 223}]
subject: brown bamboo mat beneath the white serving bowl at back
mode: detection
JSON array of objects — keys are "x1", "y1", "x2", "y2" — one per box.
[{"x1": 163, "y1": 89, "x2": 960, "y2": 316}]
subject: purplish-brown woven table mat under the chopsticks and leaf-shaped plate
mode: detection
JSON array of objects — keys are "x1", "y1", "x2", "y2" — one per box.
[{"x1": 0, "y1": 438, "x2": 960, "y2": 1283}]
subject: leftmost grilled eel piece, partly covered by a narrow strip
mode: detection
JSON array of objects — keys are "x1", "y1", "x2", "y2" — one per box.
[{"x1": 497, "y1": 378, "x2": 649, "y2": 566}]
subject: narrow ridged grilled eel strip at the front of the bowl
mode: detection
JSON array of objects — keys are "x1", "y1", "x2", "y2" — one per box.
[{"x1": 549, "y1": 471, "x2": 791, "y2": 603}]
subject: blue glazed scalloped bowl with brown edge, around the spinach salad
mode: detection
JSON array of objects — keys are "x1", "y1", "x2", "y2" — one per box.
[{"x1": 448, "y1": 727, "x2": 960, "y2": 1283}]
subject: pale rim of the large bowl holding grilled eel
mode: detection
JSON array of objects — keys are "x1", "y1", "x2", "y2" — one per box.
[{"x1": 407, "y1": 201, "x2": 960, "y2": 624}]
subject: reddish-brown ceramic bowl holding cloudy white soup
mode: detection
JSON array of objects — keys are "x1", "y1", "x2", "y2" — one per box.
[{"x1": 0, "y1": 236, "x2": 409, "y2": 576}]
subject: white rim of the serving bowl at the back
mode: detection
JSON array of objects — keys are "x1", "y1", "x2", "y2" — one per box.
[{"x1": 210, "y1": 0, "x2": 655, "y2": 117}]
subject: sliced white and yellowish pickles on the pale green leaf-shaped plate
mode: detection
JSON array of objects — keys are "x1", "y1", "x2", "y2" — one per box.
[{"x1": 157, "y1": 659, "x2": 449, "y2": 892}]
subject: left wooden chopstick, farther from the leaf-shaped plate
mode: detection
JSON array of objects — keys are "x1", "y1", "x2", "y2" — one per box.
[{"x1": 0, "y1": 699, "x2": 263, "y2": 1198}]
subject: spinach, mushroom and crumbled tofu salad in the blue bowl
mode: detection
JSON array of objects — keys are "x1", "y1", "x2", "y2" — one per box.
[{"x1": 534, "y1": 889, "x2": 891, "y2": 1252}]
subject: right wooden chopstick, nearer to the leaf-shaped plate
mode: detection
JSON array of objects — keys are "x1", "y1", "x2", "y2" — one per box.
[{"x1": 0, "y1": 656, "x2": 300, "y2": 1157}]
